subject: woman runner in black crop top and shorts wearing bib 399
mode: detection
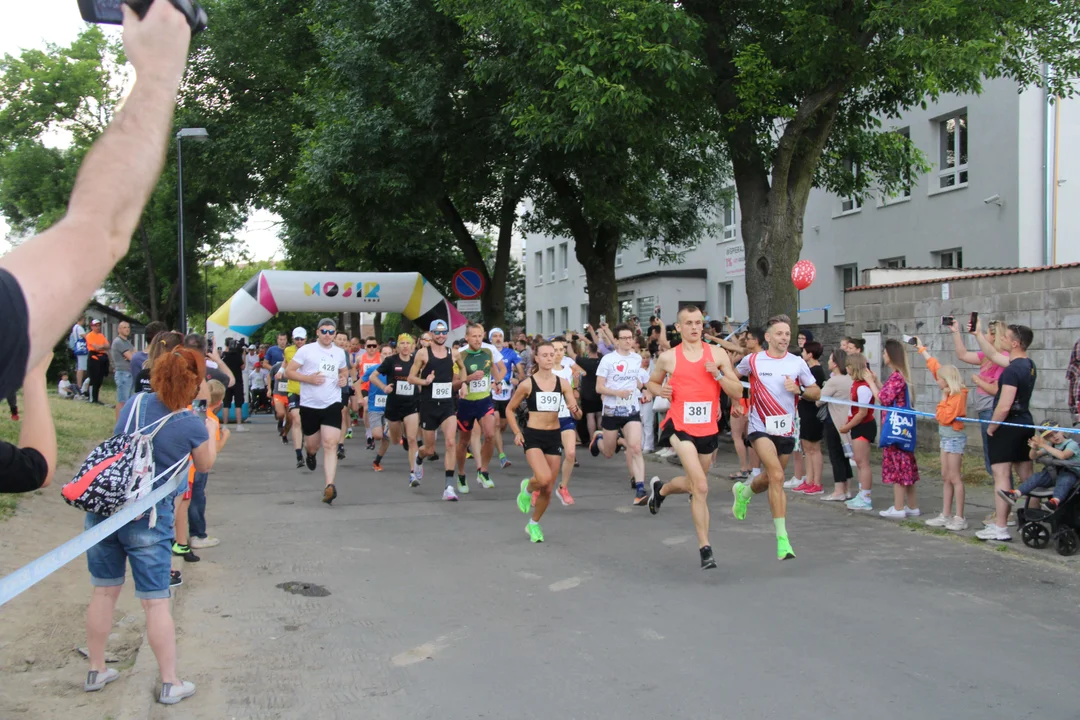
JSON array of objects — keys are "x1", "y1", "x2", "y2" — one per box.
[{"x1": 507, "y1": 342, "x2": 581, "y2": 543}]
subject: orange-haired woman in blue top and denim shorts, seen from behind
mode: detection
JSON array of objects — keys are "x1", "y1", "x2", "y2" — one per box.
[{"x1": 83, "y1": 348, "x2": 217, "y2": 705}]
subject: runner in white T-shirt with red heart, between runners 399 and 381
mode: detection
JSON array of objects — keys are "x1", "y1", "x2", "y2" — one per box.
[{"x1": 589, "y1": 324, "x2": 649, "y2": 505}]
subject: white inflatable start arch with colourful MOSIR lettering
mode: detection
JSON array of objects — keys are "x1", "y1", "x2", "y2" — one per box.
[{"x1": 206, "y1": 270, "x2": 468, "y2": 342}]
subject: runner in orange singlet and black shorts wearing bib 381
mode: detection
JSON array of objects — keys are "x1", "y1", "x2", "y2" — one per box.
[{"x1": 649, "y1": 305, "x2": 742, "y2": 570}]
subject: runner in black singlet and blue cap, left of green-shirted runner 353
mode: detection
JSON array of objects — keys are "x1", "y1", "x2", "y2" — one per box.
[{"x1": 408, "y1": 320, "x2": 469, "y2": 502}]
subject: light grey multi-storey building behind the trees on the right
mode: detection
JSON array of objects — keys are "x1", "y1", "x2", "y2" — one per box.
[{"x1": 525, "y1": 80, "x2": 1080, "y2": 334}]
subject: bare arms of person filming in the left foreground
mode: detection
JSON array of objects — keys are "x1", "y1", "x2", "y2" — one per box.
[{"x1": 0, "y1": 0, "x2": 191, "y2": 487}]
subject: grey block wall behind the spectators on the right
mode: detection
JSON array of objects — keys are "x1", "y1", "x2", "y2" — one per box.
[{"x1": 842, "y1": 267, "x2": 1080, "y2": 444}]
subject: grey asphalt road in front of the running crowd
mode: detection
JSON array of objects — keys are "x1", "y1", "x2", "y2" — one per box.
[{"x1": 153, "y1": 419, "x2": 1080, "y2": 720}]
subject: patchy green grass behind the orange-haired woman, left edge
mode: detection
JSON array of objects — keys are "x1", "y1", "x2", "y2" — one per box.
[{"x1": 0, "y1": 386, "x2": 116, "y2": 519}]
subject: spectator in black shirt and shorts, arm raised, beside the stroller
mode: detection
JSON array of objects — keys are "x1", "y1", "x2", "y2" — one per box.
[{"x1": 972, "y1": 323, "x2": 1038, "y2": 542}]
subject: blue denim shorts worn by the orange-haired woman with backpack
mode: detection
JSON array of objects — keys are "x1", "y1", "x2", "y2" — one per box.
[{"x1": 83, "y1": 507, "x2": 173, "y2": 600}]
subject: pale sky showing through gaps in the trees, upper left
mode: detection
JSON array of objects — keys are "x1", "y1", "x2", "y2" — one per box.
[{"x1": 0, "y1": 0, "x2": 283, "y2": 260}]
